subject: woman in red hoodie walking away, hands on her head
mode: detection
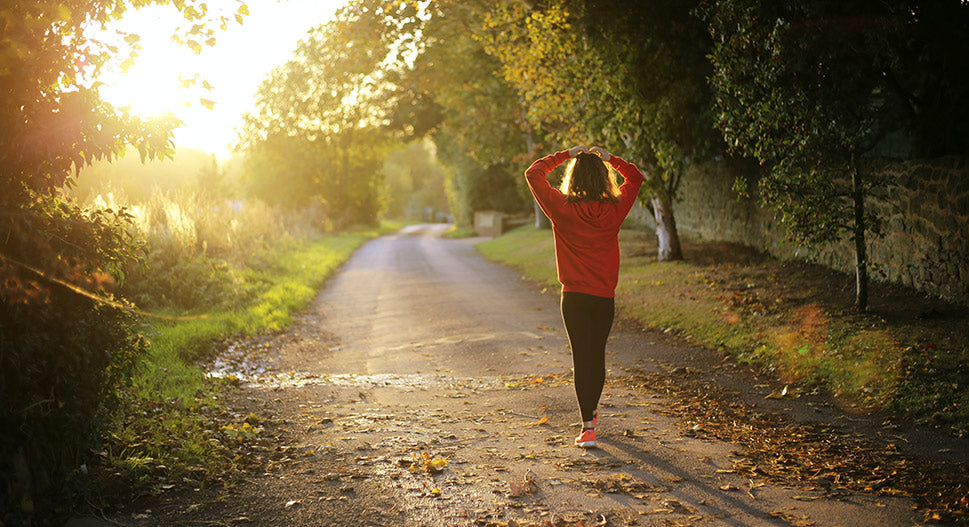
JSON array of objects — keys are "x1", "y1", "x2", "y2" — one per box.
[{"x1": 525, "y1": 146, "x2": 643, "y2": 448}]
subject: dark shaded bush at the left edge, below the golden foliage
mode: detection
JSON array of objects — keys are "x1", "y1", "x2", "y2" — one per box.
[{"x1": 0, "y1": 196, "x2": 146, "y2": 525}]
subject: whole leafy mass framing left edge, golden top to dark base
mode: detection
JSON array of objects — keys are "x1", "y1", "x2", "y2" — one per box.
[{"x1": 0, "y1": 0, "x2": 246, "y2": 524}]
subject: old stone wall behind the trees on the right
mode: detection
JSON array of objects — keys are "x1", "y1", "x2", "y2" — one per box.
[{"x1": 656, "y1": 157, "x2": 969, "y2": 305}]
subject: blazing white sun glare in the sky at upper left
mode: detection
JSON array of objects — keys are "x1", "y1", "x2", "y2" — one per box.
[{"x1": 98, "y1": 0, "x2": 347, "y2": 159}]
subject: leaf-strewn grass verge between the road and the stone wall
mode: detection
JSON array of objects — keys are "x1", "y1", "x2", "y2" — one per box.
[{"x1": 478, "y1": 226, "x2": 969, "y2": 436}]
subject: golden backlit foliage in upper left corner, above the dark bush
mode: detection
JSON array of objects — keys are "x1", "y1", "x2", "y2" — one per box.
[{"x1": 0, "y1": 0, "x2": 244, "y2": 199}]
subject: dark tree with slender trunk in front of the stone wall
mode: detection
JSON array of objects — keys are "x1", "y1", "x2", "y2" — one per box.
[{"x1": 701, "y1": 0, "x2": 969, "y2": 310}]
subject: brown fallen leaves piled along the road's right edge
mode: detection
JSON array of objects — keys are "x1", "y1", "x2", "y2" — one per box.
[{"x1": 623, "y1": 371, "x2": 969, "y2": 526}]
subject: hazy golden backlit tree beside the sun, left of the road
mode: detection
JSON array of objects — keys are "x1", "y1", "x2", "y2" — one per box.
[{"x1": 239, "y1": 1, "x2": 416, "y2": 228}]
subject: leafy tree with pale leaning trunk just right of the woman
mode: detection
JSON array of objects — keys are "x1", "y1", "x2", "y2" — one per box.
[{"x1": 482, "y1": 0, "x2": 718, "y2": 260}]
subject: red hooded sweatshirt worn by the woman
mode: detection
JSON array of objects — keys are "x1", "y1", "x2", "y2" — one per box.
[{"x1": 525, "y1": 150, "x2": 643, "y2": 298}]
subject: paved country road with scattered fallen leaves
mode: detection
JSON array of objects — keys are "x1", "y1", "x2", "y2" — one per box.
[{"x1": 113, "y1": 226, "x2": 916, "y2": 527}]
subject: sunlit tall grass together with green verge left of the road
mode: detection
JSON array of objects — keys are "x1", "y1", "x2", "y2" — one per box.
[{"x1": 82, "y1": 185, "x2": 397, "y2": 505}]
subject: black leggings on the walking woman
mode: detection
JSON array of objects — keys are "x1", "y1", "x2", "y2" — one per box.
[{"x1": 562, "y1": 292, "x2": 616, "y2": 421}]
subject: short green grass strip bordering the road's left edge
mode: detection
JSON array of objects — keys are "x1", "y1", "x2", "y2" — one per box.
[{"x1": 99, "y1": 224, "x2": 399, "y2": 504}]
